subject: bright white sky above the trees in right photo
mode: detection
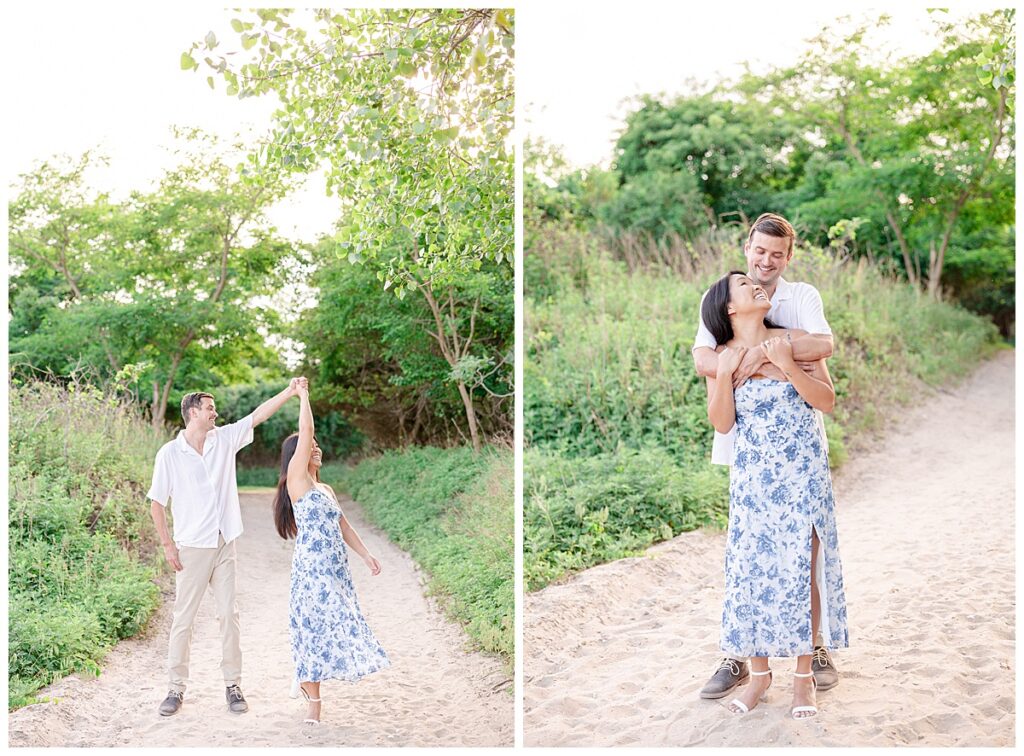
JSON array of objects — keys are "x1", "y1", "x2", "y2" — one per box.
[{"x1": 516, "y1": 0, "x2": 1006, "y2": 167}]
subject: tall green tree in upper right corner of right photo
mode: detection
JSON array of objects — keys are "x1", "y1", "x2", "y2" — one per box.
[{"x1": 757, "y1": 11, "x2": 1015, "y2": 297}]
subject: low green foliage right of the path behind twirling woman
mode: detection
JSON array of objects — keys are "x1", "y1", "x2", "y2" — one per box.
[{"x1": 322, "y1": 447, "x2": 515, "y2": 669}]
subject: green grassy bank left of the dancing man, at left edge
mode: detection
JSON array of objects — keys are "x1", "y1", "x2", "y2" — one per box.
[{"x1": 7, "y1": 382, "x2": 163, "y2": 708}]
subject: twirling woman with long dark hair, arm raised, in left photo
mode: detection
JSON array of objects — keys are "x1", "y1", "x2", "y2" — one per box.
[{"x1": 273, "y1": 385, "x2": 391, "y2": 724}]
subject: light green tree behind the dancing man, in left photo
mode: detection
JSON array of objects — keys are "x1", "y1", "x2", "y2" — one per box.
[{"x1": 10, "y1": 132, "x2": 292, "y2": 425}]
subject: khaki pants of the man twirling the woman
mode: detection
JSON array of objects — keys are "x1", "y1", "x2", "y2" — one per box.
[{"x1": 167, "y1": 536, "x2": 242, "y2": 692}]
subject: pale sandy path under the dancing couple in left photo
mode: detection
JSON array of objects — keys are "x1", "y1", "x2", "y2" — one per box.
[{"x1": 8, "y1": 495, "x2": 513, "y2": 746}]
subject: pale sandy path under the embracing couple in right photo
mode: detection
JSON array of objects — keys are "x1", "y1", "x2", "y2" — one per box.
[{"x1": 523, "y1": 351, "x2": 1015, "y2": 746}]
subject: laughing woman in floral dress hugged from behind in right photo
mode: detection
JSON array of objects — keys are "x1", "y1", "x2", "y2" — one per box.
[{"x1": 701, "y1": 270, "x2": 849, "y2": 719}]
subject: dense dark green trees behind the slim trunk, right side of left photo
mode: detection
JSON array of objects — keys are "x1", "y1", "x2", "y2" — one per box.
[{"x1": 296, "y1": 242, "x2": 514, "y2": 447}]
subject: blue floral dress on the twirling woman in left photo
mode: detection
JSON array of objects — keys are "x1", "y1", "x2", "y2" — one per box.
[{"x1": 289, "y1": 488, "x2": 391, "y2": 682}]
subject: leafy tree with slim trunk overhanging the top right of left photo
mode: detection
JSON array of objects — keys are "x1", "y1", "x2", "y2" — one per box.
[{"x1": 187, "y1": 9, "x2": 514, "y2": 449}]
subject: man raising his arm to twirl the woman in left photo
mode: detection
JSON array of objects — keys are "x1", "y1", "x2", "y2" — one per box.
[{"x1": 146, "y1": 378, "x2": 306, "y2": 716}]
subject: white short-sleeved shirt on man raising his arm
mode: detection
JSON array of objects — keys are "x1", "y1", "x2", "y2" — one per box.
[{"x1": 146, "y1": 415, "x2": 253, "y2": 548}]
